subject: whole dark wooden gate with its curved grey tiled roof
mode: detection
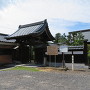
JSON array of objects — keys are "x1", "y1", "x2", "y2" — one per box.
[{"x1": 7, "y1": 20, "x2": 54, "y2": 64}]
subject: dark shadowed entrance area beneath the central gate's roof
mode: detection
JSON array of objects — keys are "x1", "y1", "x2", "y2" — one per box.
[{"x1": 13, "y1": 44, "x2": 45, "y2": 64}]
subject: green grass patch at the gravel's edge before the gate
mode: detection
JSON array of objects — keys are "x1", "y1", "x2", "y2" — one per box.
[{"x1": 2, "y1": 66, "x2": 40, "y2": 72}]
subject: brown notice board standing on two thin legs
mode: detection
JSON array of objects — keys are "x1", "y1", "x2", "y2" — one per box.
[{"x1": 47, "y1": 45, "x2": 58, "y2": 67}]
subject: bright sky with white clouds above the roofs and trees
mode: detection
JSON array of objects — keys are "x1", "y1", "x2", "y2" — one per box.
[{"x1": 0, "y1": 0, "x2": 90, "y2": 36}]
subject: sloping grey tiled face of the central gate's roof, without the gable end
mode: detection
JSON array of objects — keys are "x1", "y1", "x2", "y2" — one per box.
[{"x1": 7, "y1": 20, "x2": 47, "y2": 38}]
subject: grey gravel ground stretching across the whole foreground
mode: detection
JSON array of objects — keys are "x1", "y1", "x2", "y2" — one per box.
[{"x1": 0, "y1": 71, "x2": 90, "y2": 90}]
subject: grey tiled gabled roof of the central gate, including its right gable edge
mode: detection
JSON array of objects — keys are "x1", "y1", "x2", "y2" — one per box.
[{"x1": 7, "y1": 20, "x2": 54, "y2": 40}]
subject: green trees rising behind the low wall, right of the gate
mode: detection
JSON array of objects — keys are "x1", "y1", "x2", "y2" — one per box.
[{"x1": 54, "y1": 32, "x2": 84, "y2": 46}]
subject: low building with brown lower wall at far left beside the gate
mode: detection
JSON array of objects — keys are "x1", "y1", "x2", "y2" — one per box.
[{"x1": 0, "y1": 33, "x2": 17, "y2": 65}]
